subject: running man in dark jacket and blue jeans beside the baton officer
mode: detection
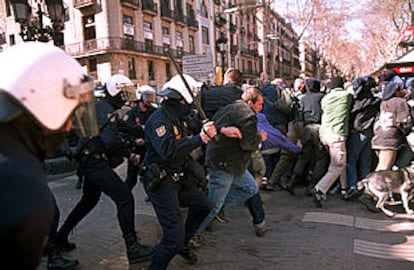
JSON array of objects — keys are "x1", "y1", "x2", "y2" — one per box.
[{"x1": 194, "y1": 87, "x2": 267, "y2": 247}]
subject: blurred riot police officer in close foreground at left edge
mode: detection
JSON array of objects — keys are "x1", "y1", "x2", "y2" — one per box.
[{"x1": 0, "y1": 42, "x2": 98, "y2": 269}]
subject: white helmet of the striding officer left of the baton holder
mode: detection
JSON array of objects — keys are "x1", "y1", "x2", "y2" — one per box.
[{"x1": 106, "y1": 74, "x2": 136, "y2": 101}]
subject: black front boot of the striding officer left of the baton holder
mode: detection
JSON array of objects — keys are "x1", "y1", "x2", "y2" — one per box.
[{"x1": 124, "y1": 232, "x2": 155, "y2": 264}]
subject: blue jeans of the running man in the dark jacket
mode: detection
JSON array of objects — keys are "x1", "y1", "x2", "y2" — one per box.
[{"x1": 195, "y1": 168, "x2": 265, "y2": 235}]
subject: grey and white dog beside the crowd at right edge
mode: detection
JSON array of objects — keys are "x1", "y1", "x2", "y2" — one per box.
[{"x1": 357, "y1": 163, "x2": 414, "y2": 217}]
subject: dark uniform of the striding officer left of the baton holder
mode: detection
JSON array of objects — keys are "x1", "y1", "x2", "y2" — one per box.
[{"x1": 58, "y1": 97, "x2": 154, "y2": 262}]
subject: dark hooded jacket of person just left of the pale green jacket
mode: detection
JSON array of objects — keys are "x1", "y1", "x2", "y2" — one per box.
[{"x1": 302, "y1": 78, "x2": 324, "y2": 125}]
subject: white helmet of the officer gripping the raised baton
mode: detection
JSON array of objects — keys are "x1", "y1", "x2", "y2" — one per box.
[{"x1": 158, "y1": 74, "x2": 202, "y2": 104}]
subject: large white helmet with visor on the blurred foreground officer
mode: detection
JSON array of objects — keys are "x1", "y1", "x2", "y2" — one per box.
[{"x1": 0, "y1": 42, "x2": 98, "y2": 136}]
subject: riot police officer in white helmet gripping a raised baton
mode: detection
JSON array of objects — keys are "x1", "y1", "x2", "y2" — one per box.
[{"x1": 144, "y1": 75, "x2": 216, "y2": 269}]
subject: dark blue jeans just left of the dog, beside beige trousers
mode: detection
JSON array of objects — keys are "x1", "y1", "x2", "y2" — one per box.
[{"x1": 346, "y1": 131, "x2": 373, "y2": 187}]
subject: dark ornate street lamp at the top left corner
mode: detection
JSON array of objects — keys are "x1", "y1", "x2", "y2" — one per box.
[{"x1": 10, "y1": 0, "x2": 65, "y2": 46}]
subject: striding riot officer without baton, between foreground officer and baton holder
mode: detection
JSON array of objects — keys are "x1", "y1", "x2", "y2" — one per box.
[{"x1": 58, "y1": 74, "x2": 153, "y2": 264}]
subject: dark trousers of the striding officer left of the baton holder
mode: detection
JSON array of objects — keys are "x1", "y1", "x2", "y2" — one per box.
[{"x1": 64, "y1": 158, "x2": 135, "y2": 235}]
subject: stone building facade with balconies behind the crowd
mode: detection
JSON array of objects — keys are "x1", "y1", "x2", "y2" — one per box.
[{"x1": 0, "y1": 0, "x2": 320, "y2": 89}]
